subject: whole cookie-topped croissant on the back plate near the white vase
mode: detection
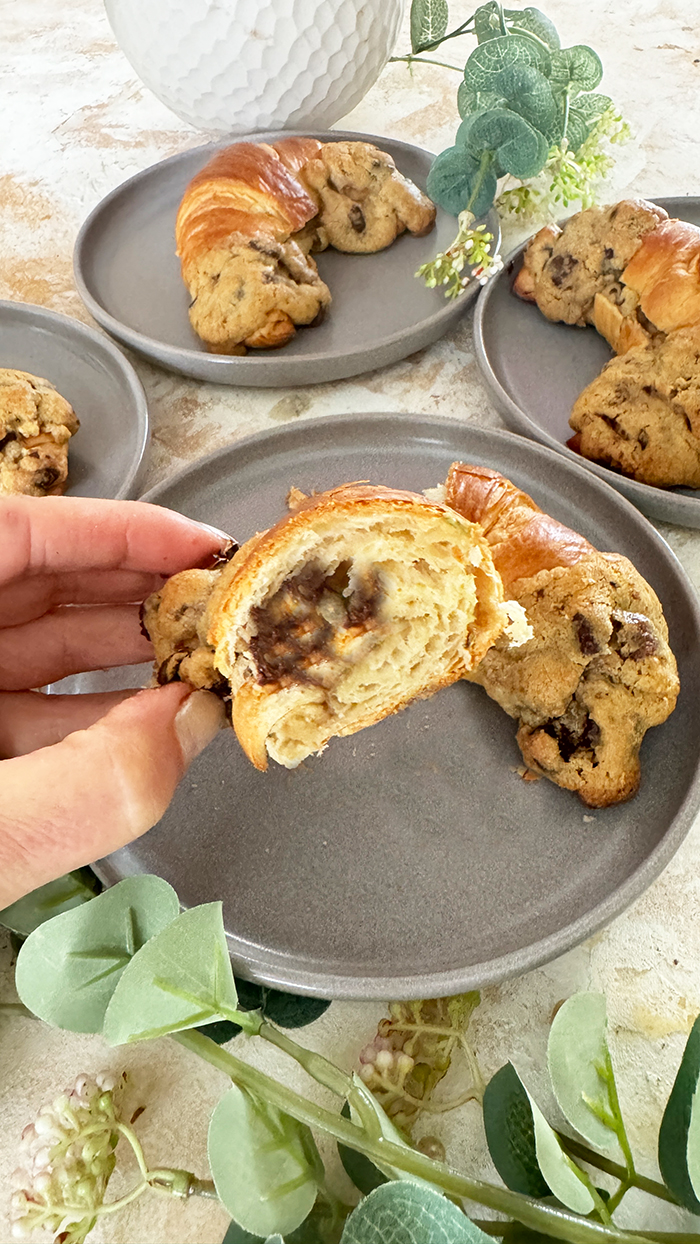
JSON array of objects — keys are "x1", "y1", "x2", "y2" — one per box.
[{"x1": 175, "y1": 138, "x2": 435, "y2": 353}]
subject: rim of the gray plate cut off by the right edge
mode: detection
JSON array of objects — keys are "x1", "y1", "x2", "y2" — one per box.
[{"x1": 474, "y1": 194, "x2": 700, "y2": 527}]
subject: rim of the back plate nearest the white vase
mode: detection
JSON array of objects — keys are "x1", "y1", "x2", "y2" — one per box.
[{"x1": 73, "y1": 129, "x2": 501, "y2": 387}]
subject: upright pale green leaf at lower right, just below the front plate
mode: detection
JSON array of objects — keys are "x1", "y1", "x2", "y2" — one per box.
[{"x1": 547, "y1": 993, "x2": 617, "y2": 1149}]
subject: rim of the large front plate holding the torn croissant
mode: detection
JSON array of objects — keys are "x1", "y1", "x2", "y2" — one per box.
[{"x1": 133, "y1": 411, "x2": 700, "y2": 1000}]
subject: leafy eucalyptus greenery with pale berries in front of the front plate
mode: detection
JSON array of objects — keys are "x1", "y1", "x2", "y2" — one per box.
[{"x1": 4, "y1": 877, "x2": 700, "y2": 1244}]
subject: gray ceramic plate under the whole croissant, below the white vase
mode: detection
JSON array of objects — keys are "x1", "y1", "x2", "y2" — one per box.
[{"x1": 75, "y1": 131, "x2": 500, "y2": 387}]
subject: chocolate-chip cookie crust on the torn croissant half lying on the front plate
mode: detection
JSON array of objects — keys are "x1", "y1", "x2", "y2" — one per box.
[{"x1": 469, "y1": 551, "x2": 679, "y2": 807}]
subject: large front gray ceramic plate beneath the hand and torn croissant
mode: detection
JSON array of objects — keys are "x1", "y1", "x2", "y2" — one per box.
[{"x1": 90, "y1": 414, "x2": 700, "y2": 998}]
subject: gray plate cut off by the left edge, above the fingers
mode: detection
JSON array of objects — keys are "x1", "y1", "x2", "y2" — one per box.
[{"x1": 0, "y1": 302, "x2": 148, "y2": 498}]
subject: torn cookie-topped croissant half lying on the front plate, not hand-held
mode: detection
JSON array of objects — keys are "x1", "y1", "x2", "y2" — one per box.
[{"x1": 445, "y1": 463, "x2": 679, "y2": 807}]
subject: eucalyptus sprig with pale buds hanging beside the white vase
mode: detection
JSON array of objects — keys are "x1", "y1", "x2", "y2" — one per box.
[{"x1": 402, "y1": 0, "x2": 629, "y2": 297}]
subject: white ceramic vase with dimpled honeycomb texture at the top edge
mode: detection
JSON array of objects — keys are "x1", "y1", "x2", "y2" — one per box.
[{"x1": 106, "y1": 0, "x2": 404, "y2": 134}]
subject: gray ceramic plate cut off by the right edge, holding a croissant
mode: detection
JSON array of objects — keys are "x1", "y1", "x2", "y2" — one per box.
[{"x1": 474, "y1": 198, "x2": 700, "y2": 527}]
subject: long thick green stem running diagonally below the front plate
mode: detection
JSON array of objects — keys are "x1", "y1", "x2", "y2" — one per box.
[{"x1": 173, "y1": 1029, "x2": 656, "y2": 1244}]
